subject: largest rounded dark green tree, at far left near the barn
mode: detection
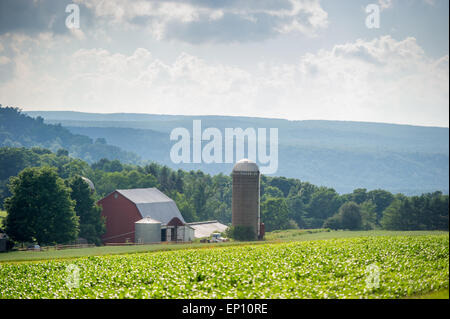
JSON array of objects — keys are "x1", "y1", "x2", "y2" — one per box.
[{"x1": 5, "y1": 167, "x2": 79, "y2": 245}]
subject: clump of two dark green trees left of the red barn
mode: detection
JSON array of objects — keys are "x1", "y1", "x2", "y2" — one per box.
[{"x1": 4, "y1": 166, "x2": 105, "y2": 245}]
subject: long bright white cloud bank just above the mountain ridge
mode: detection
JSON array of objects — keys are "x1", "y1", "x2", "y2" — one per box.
[{"x1": 0, "y1": 36, "x2": 449, "y2": 126}]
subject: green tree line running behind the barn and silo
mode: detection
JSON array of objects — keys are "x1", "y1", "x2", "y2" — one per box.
[{"x1": 0, "y1": 147, "x2": 449, "y2": 248}]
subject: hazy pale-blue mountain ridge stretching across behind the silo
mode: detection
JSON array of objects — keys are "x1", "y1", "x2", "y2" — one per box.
[{"x1": 27, "y1": 111, "x2": 449, "y2": 195}]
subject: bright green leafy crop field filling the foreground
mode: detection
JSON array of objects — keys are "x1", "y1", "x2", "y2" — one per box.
[{"x1": 0, "y1": 233, "x2": 449, "y2": 298}]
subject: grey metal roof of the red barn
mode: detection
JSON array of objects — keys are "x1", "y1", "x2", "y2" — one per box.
[{"x1": 117, "y1": 187, "x2": 185, "y2": 225}]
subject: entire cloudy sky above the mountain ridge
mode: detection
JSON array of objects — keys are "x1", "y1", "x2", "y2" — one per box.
[{"x1": 0, "y1": 0, "x2": 449, "y2": 127}]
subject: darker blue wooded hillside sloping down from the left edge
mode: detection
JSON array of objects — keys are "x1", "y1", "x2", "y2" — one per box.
[{"x1": 0, "y1": 105, "x2": 139, "y2": 163}]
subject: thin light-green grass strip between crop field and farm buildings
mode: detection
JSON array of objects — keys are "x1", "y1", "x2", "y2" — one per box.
[{"x1": 0, "y1": 229, "x2": 448, "y2": 263}]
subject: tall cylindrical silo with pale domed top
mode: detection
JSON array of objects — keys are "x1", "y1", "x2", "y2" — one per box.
[{"x1": 231, "y1": 159, "x2": 260, "y2": 239}]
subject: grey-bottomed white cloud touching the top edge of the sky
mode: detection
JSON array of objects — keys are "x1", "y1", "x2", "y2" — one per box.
[{"x1": 76, "y1": 0, "x2": 328, "y2": 42}]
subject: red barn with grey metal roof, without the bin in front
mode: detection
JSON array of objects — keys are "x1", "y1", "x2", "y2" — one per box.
[{"x1": 98, "y1": 188, "x2": 185, "y2": 243}]
